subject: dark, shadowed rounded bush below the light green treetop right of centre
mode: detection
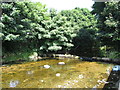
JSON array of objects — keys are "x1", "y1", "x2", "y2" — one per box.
[{"x1": 71, "y1": 29, "x2": 99, "y2": 57}]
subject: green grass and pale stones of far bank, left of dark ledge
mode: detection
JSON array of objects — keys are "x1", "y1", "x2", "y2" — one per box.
[{"x1": 0, "y1": 52, "x2": 79, "y2": 65}]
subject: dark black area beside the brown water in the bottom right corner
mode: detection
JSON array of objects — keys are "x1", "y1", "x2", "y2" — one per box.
[{"x1": 103, "y1": 65, "x2": 120, "y2": 90}]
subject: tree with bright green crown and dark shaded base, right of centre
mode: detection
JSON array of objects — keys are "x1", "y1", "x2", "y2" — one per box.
[{"x1": 61, "y1": 8, "x2": 99, "y2": 56}]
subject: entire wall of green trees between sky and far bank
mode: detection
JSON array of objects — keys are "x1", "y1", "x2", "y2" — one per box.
[{"x1": 0, "y1": 2, "x2": 120, "y2": 60}]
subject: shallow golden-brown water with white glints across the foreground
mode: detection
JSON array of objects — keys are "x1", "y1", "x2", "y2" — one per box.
[{"x1": 0, "y1": 59, "x2": 112, "y2": 88}]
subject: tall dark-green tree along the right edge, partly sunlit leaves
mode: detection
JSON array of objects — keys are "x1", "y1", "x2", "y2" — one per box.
[{"x1": 92, "y1": 2, "x2": 120, "y2": 57}]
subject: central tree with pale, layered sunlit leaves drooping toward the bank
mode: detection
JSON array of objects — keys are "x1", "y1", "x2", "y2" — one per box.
[{"x1": 39, "y1": 13, "x2": 76, "y2": 53}]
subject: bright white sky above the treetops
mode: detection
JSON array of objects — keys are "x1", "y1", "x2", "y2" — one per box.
[{"x1": 31, "y1": 0, "x2": 94, "y2": 11}]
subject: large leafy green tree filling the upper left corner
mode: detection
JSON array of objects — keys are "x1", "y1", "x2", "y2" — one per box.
[{"x1": 0, "y1": 2, "x2": 48, "y2": 51}]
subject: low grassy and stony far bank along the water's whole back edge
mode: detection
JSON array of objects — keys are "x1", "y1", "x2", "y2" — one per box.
[{"x1": 1, "y1": 52, "x2": 120, "y2": 65}]
